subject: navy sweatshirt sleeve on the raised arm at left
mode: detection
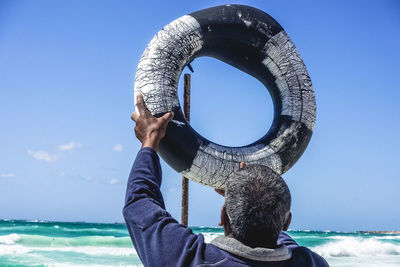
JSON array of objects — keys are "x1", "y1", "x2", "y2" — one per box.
[{"x1": 123, "y1": 148, "x2": 204, "y2": 266}]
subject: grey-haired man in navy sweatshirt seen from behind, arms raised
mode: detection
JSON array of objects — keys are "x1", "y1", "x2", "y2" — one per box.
[{"x1": 123, "y1": 94, "x2": 328, "y2": 266}]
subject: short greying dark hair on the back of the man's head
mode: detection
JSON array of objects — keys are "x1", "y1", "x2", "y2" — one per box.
[{"x1": 225, "y1": 165, "x2": 291, "y2": 247}]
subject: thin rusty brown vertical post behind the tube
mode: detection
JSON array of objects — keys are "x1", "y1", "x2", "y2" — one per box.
[{"x1": 181, "y1": 74, "x2": 190, "y2": 226}]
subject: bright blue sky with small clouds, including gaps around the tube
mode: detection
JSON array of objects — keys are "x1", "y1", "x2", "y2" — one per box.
[{"x1": 0, "y1": 0, "x2": 400, "y2": 231}]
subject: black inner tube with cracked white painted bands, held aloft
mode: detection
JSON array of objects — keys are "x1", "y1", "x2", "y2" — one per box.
[{"x1": 134, "y1": 5, "x2": 316, "y2": 189}]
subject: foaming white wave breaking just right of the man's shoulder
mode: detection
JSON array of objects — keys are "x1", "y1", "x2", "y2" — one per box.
[{"x1": 311, "y1": 237, "x2": 400, "y2": 257}]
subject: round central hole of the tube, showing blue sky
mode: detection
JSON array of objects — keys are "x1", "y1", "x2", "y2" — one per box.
[{"x1": 178, "y1": 57, "x2": 274, "y2": 147}]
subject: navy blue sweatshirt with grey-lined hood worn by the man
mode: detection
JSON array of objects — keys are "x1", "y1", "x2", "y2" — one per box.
[{"x1": 123, "y1": 148, "x2": 328, "y2": 267}]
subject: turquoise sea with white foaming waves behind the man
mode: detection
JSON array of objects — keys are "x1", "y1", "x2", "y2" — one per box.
[{"x1": 0, "y1": 220, "x2": 400, "y2": 267}]
